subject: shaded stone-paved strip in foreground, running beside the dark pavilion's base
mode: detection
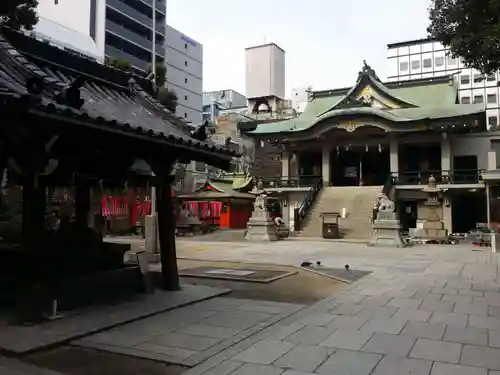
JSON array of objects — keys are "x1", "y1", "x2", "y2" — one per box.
[{"x1": 72, "y1": 297, "x2": 304, "y2": 366}]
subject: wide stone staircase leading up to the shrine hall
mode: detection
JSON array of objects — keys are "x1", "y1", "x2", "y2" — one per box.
[{"x1": 299, "y1": 186, "x2": 382, "y2": 240}]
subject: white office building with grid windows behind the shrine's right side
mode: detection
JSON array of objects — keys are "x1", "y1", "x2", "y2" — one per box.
[{"x1": 387, "y1": 39, "x2": 500, "y2": 126}]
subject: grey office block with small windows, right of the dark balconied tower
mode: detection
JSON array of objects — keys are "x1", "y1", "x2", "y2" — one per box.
[{"x1": 165, "y1": 25, "x2": 203, "y2": 125}]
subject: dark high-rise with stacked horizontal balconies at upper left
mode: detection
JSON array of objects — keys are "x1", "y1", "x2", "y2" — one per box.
[{"x1": 105, "y1": 0, "x2": 167, "y2": 74}]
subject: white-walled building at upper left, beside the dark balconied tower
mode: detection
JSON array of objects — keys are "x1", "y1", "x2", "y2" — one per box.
[{"x1": 33, "y1": 0, "x2": 106, "y2": 62}]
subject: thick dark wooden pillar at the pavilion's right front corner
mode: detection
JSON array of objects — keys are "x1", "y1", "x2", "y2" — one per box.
[{"x1": 156, "y1": 175, "x2": 180, "y2": 290}]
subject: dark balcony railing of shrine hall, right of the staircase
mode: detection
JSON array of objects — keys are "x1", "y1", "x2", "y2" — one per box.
[{"x1": 392, "y1": 169, "x2": 482, "y2": 185}]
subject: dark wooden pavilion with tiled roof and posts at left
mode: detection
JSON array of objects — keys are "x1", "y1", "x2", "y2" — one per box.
[{"x1": 0, "y1": 28, "x2": 236, "y2": 318}]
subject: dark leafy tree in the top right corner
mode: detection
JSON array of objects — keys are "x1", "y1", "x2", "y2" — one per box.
[{"x1": 427, "y1": 0, "x2": 500, "y2": 74}]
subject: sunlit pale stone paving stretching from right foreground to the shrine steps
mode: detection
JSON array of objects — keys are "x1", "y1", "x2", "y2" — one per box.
[{"x1": 173, "y1": 241, "x2": 500, "y2": 375}]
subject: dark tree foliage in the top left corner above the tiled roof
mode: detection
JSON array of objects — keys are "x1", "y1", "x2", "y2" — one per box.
[{"x1": 0, "y1": 0, "x2": 38, "y2": 30}]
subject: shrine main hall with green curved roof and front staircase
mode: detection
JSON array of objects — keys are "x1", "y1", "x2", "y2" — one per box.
[{"x1": 240, "y1": 62, "x2": 500, "y2": 237}]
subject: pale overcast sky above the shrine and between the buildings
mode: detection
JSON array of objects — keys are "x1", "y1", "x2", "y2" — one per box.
[{"x1": 167, "y1": 0, "x2": 429, "y2": 94}]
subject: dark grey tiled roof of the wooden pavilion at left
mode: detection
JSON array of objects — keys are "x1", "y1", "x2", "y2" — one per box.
[{"x1": 0, "y1": 29, "x2": 237, "y2": 158}]
